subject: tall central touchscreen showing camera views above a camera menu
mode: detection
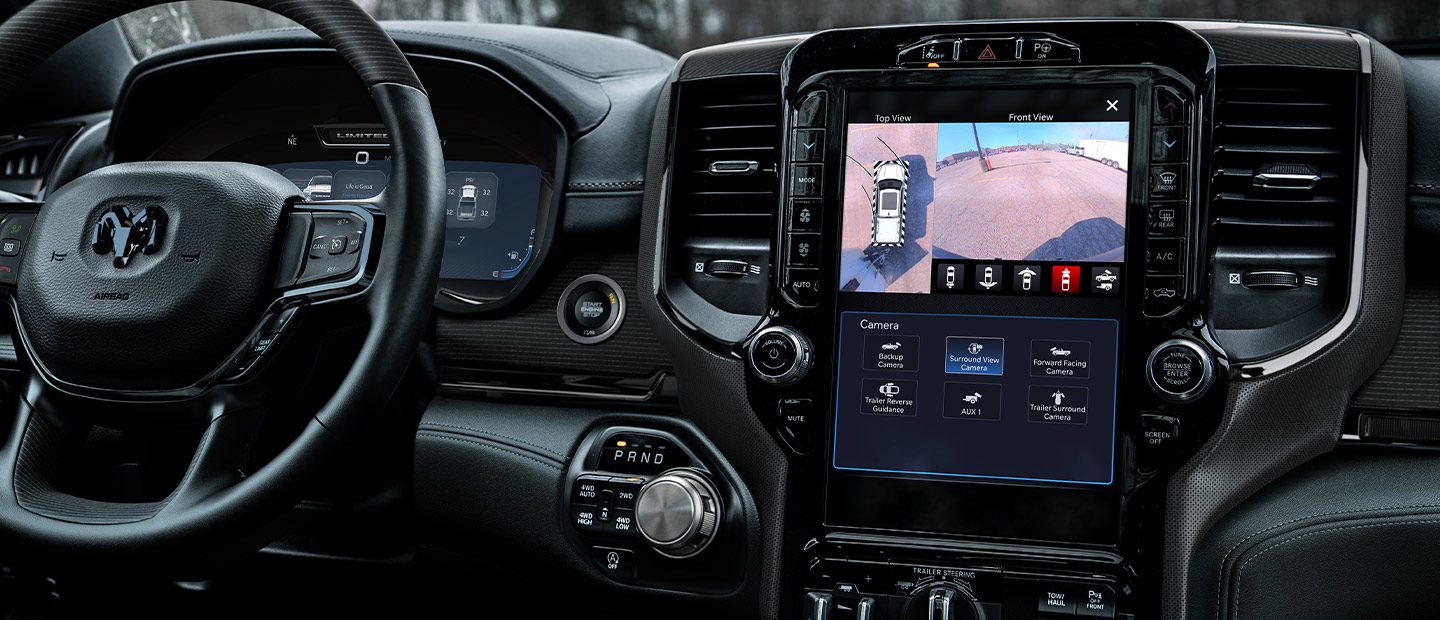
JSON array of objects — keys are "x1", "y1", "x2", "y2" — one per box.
[{"x1": 831, "y1": 86, "x2": 1132, "y2": 485}]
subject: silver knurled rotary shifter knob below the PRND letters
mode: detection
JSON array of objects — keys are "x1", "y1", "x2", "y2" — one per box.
[{"x1": 635, "y1": 469, "x2": 723, "y2": 558}]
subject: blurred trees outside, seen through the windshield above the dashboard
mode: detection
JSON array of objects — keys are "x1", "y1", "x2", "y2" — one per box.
[{"x1": 124, "y1": 0, "x2": 1440, "y2": 56}]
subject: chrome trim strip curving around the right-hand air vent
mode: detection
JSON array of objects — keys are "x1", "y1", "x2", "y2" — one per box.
[{"x1": 1211, "y1": 33, "x2": 1374, "y2": 378}]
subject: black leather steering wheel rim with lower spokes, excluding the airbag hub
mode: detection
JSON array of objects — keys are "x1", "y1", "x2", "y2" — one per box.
[{"x1": 0, "y1": 0, "x2": 444, "y2": 560}]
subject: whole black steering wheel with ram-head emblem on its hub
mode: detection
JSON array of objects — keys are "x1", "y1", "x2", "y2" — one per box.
[{"x1": 0, "y1": 0, "x2": 445, "y2": 560}]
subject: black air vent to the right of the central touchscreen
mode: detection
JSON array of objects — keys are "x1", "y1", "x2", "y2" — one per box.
[{"x1": 1210, "y1": 66, "x2": 1358, "y2": 361}]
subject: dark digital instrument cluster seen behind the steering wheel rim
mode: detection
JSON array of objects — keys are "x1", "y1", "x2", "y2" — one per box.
[{"x1": 112, "y1": 50, "x2": 566, "y2": 314}]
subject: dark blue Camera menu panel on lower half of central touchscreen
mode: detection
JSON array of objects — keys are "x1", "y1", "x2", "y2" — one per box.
[{"x1": 832, "y1": 312, "x2": 1119, "y2": 485}]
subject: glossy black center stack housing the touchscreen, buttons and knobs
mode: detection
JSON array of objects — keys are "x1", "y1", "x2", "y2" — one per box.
[{"x1": 744, "y1": 22, "x2": 1225, "y2": 619}]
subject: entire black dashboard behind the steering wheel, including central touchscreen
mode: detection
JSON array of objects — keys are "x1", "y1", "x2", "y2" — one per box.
[{"x1": 14, "y1": 13, "x2": 1440, "y2": 620}]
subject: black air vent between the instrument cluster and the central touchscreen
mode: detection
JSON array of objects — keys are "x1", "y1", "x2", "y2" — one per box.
[{"x1": 668, "y1": 75, "x2": 783, "y2": 339}]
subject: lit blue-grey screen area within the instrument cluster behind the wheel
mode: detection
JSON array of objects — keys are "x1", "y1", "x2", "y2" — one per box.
[{"x1": 271, "y1": 158, "x2": 540, "y2": 281}]
